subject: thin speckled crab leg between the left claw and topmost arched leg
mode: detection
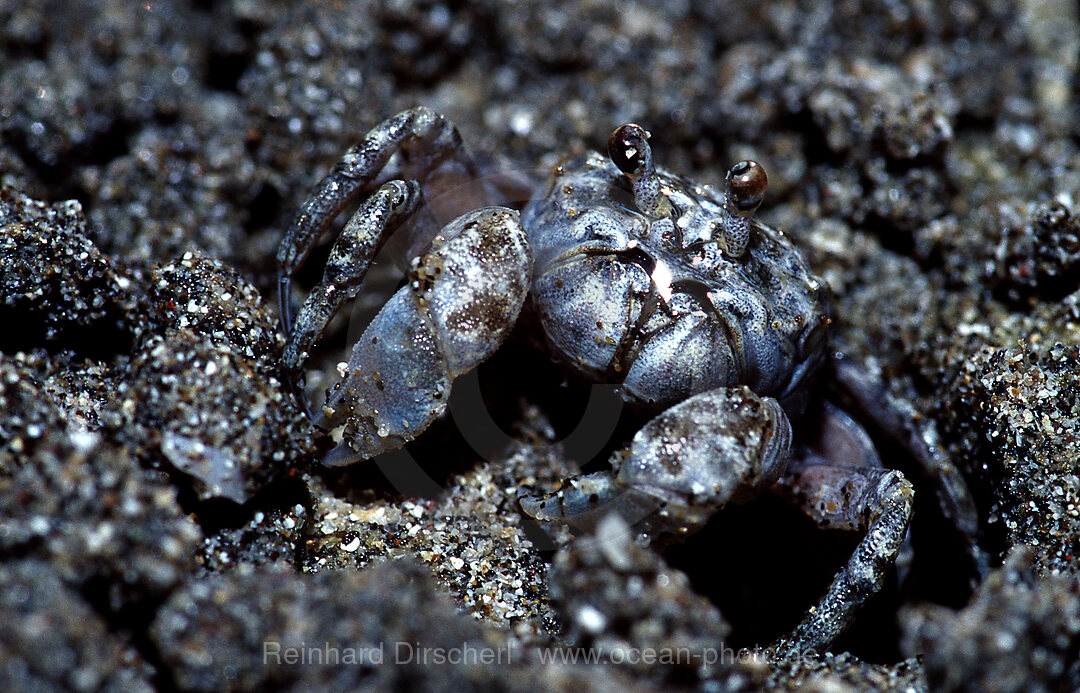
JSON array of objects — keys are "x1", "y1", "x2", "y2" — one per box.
[{"x1": 282, "y1": 180, "x2": 421, "y2": 371}]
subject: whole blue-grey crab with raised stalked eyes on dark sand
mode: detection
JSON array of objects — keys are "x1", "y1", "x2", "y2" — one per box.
[{"x1": 278, "y1": 107, "x2": 973, "y2": 653}]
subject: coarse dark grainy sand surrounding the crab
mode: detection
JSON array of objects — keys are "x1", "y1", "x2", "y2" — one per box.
[{"x1": 0, "y1": 0, "x2": 1080, "y2": 691}]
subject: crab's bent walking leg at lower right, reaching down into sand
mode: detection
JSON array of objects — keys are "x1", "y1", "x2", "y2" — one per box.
[{"x1": 777, "y1": 462, "x2": 915, "y2": 656}]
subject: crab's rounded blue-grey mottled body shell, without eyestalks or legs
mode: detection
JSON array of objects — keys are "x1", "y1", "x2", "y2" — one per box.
[{"x1": 522, "y1": 152, "x2": 831, "y2": 416}]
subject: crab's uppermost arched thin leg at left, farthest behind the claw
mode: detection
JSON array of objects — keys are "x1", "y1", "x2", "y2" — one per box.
[{"x1": 278, "y1": 107, "x2": 476, "y2": 335}]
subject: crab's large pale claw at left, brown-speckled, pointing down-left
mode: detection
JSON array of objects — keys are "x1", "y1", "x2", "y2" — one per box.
[{"x1": 315, "y1": 207, "x2": 532, "y2": 466}]
